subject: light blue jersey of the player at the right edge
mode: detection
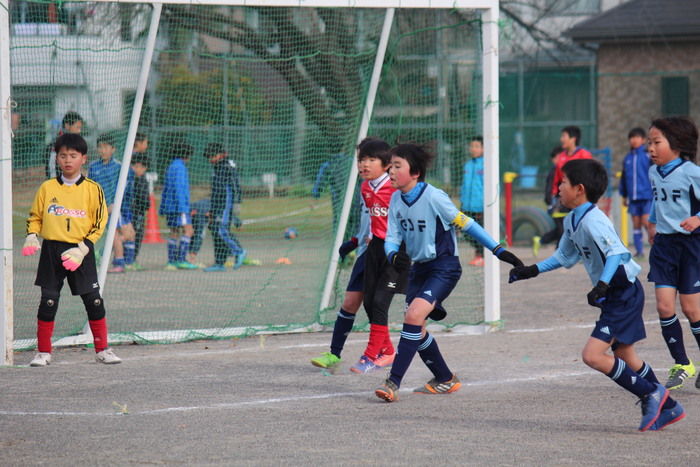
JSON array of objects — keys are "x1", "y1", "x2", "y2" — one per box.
[{"x1": 649, "y1": 159, "x2": 700, "y2": 235}]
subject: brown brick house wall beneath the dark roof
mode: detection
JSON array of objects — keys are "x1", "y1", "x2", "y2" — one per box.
[{"x1": 598, "y1": 40, "x2": 700, "y2": 170}]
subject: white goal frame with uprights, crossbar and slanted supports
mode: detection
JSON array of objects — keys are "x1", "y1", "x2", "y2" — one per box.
[{"x1": 0, "y1": 0, "x2": 500, "y2": 365}]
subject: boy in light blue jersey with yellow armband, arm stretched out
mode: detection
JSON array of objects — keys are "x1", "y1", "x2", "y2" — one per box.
[{"x1": 375, "y1": 144, "x2": 523, "y2": 402}]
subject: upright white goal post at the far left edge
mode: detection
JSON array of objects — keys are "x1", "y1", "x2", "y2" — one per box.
[{"x1": 0, "y1": 0, "x2": 14, "y2": 365}]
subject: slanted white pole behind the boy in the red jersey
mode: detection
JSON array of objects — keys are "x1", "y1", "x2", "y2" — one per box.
[{"x1": 320, "y1": 8, "x2": 394, "y2": 311}]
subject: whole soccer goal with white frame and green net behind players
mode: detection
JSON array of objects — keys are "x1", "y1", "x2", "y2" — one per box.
[{"x1": 0, "y1": 0, "x2": 500, "y2": 364}]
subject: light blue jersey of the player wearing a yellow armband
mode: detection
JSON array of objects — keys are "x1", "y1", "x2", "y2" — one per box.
[{"x1": 386, "y1": 183, "x2": 474, "y2": 263}]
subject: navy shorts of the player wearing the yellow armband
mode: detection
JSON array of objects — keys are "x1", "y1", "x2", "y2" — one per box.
[{"x1": 406, "y1": 256, "x2": 462, "y2": 321}]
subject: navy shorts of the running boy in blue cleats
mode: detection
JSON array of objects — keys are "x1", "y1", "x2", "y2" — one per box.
[{"x1": 591, "y1": 279, "x2": 647, "y2": 345}]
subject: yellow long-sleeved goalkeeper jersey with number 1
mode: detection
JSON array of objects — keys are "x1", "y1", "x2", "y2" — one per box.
[{"x1": 27, "y1": 175, "x2": 107, "y2": 244}]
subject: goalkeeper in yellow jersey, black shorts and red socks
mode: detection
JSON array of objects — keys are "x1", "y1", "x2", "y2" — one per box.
[{"x1": 22, "y1": 134, "x2": 121, "y2": 366}]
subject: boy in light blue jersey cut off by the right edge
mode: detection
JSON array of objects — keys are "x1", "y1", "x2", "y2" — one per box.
[{"x1": 648, "y1": 116, "x2": 700, "y2": 389}]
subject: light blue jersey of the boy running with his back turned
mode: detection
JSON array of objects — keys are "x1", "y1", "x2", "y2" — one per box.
[{"x1": 553, "y1": 203, "x2": 642, "y2": 285}]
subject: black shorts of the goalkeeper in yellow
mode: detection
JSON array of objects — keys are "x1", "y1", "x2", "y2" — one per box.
[{"x1": 34, "y1": 239, "x2": 100, "y2": 295}]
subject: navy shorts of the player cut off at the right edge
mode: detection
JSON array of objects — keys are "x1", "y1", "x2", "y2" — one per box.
[{"x1": 647, "y1": 234, "x2": 700, "y2": 295}]
